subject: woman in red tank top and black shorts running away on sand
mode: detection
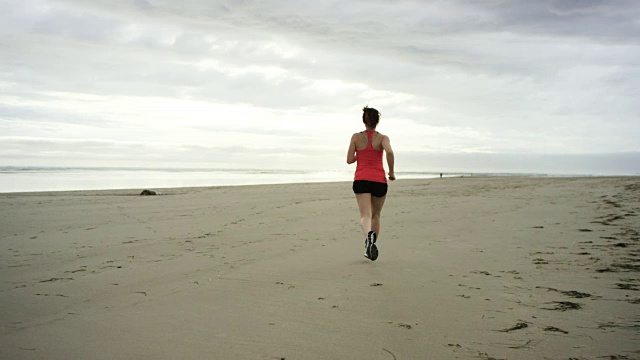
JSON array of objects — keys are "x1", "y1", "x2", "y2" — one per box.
[{"x1": 347, "y1": 106, "x2": 396, "y2": 261}]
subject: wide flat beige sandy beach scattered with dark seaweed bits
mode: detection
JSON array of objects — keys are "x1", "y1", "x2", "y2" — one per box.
[{"x1": 0, "y1": 177, "x2": 640, "y2": 360}]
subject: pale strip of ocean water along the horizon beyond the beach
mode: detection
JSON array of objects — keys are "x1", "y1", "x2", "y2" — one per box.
[{"x1": 0, "y1": 166, "x2": 464, "y2": 193}]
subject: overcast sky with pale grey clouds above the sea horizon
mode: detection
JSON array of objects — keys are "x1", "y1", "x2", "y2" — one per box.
[{"x1": 0, "y1": 0, "x2": 640, "y2": 173}]
